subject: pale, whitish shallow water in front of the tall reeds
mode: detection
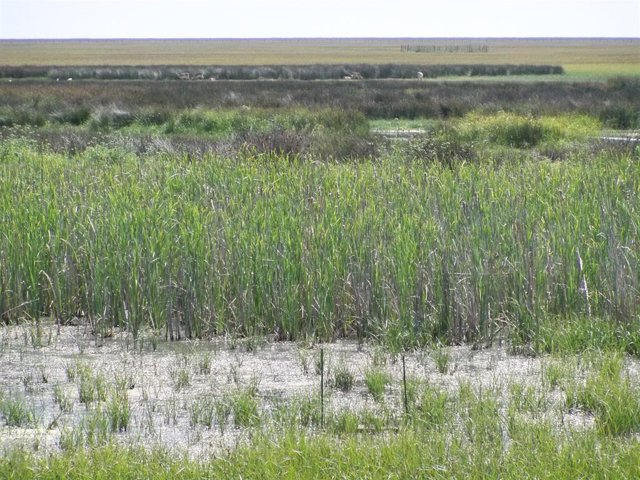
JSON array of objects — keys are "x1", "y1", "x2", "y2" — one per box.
[{"x1": 0, "y1": 325, "x2": 640, "y2": 457}]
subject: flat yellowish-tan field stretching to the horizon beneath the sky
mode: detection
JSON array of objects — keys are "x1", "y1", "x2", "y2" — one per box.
[{"x1": 0, "y1": 38, "x2": 640, "y2": 76}]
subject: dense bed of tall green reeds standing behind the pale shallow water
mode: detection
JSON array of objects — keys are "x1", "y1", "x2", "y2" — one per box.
[{"x1": 0, "y1": 140, "x2": 640, "y2": 346}]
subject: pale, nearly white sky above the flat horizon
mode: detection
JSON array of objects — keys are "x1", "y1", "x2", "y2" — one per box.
[{"x1": 0, "y1": 0, "x2": 640, "y2": 39}]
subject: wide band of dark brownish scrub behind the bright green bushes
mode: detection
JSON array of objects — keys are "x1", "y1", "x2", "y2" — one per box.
[{"x1": 0, "y1": 78, "x2": 640, "y2": 129}]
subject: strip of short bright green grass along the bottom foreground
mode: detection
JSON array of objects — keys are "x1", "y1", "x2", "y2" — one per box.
[{"x1": 0, "y1": 427, "x2": 640, "y2": 480}]
